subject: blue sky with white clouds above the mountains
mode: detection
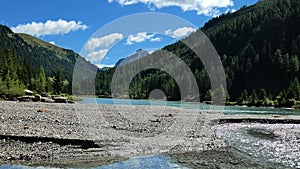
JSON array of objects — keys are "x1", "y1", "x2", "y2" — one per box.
[{"x1": 0, "y1": 0, "x2": 257, "y2": 68}]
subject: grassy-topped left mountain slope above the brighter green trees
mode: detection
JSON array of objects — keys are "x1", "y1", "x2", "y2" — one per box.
[{"x1": 0, "y1": 25, "x2": 95, "y2": 80}]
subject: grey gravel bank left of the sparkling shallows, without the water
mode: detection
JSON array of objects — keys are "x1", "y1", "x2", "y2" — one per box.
[{"x1": 0, "y1": 101, "x2": 299, "y2": 167}]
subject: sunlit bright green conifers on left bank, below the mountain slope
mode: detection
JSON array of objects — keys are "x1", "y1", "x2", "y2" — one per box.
[{"x1": 0, "y1": 48, "x2": 71, "y2": 99}]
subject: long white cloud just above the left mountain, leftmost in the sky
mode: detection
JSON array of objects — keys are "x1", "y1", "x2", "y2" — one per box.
[{"x1": 11, "y1": 19, "x2": 87, "y2": 36}]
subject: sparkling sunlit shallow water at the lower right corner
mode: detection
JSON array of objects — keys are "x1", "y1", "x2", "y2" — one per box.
[{"x1": 217, "y1": 124, "x2": 300, "y2": 168}]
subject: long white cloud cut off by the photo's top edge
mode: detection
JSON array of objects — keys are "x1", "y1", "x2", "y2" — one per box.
[{"x1": 108, "y1": 0, "x2": 233, "y2": 16}]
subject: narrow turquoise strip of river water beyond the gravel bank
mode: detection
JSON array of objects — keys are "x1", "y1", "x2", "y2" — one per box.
[{"x1": 81, "y1": 98, "x2": 300, "y2": 115}]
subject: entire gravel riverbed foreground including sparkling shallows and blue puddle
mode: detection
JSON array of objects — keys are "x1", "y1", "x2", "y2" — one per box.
[{"x1": 0, "y1": 101, "x2": 300, "y2": 168}]
